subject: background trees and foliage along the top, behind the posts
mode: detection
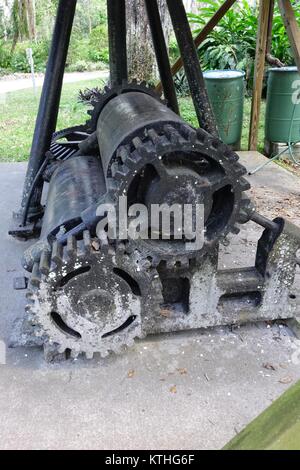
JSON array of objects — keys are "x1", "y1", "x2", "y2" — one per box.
[{"x1": 0, "y1": 0, "x2": 300, "y2": 77}]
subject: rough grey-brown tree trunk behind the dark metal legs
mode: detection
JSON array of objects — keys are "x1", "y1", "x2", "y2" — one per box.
[{"x1": 127, "y1": 0, "x2": 171, "y2": 82}]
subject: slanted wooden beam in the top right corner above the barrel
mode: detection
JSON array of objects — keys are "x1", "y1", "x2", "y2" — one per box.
[{"x1": 278, "y1": 0, "x2": 300, "y2": 73}]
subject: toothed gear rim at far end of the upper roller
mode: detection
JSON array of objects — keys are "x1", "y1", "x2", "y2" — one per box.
[{"x1": 86, "y1": 80, "x2": 166, "y2": 132}]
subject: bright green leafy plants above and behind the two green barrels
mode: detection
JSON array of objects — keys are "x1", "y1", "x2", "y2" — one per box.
[{"x1": 189, "y1": 0, "x2": 300, "y2": 78}]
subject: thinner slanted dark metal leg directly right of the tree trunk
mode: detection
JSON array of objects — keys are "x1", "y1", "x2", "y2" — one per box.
[{"x1": 145, "y1": 0, "x2": 179, "y2": 114}]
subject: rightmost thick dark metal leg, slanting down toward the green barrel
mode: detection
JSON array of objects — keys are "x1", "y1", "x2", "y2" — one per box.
[{"x1": 167, "y1": 0, "x2": 218, "y2": 137}]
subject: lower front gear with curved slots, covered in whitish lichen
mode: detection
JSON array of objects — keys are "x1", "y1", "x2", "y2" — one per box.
[{"x1": 27, "y1": 232, "x2": 161, "y2": 359}]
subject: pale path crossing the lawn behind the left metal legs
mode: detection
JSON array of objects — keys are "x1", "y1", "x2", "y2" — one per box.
[{"x1": 0, "y1": 71, "x2": 108, "y2": 94}]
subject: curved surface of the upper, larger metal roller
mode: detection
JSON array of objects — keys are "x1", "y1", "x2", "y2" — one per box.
[{"x1": 97, "y1": 92, "x2": 183, "y2": 176}]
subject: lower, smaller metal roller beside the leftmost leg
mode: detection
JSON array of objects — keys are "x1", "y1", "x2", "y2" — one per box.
[{"x1": 41, "y1": 156, "x2": 106, "y2": 241}]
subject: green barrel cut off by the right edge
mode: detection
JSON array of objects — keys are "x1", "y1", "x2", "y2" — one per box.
[{"x1": 265, "y1": 67, "x2": 300, "y2": 143}]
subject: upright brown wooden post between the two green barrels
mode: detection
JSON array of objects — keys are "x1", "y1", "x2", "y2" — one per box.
[{"x1": 249, "y1": 0, "x2": 272, "y2": 150}]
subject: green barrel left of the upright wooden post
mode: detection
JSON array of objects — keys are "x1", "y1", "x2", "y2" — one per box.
[{"x1": 204, "y1": 70, "x2": 245, "y2": 150}]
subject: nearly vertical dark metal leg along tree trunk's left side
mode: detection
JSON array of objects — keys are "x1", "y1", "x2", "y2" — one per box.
[{"x1": 107, "y1": 0, "x2": 128, "y2": 86}]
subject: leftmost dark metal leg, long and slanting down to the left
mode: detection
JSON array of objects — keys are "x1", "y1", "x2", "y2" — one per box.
[{"x1": 21, "y1": 0, "x2": 77, "y2": 218}]
